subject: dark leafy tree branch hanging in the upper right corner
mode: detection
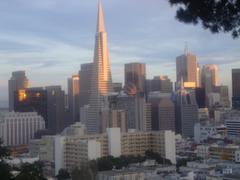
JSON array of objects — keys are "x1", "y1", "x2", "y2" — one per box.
[{"x1": 169, "y1": 0, "x2": 240, "y2": 38}]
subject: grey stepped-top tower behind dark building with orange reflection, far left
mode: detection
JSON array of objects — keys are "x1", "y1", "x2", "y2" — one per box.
[{"x1": 8, "y1": 71, "x2": 28, "y2": 111}]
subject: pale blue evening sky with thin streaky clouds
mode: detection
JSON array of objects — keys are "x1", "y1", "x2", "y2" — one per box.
[{"x1": 0, "y1": 0, "x2": 240, "y2": 102}]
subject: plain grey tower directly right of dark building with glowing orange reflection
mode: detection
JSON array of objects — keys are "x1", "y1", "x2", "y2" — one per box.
[{"x1": 46, "y1": 86, "x2": 65, "y2": 134}]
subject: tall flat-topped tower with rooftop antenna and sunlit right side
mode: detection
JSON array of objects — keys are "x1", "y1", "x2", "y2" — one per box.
[{"x1": 176, "y1": 53, "x2": 198, "y2": 87}]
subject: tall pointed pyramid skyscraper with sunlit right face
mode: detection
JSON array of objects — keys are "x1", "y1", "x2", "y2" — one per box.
[{"x1": 86, "y1": 1, "x2": 112, "y2": 133}]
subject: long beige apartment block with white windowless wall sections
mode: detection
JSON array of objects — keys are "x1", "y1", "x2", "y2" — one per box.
[{"x1": 55, "y1": 128, "x2": 176, "y2": 173}]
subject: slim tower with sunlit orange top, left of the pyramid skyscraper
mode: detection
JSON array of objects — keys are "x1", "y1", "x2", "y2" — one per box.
[{"x1": 68, "y1": 75, "x2": 80, "y2": 124}]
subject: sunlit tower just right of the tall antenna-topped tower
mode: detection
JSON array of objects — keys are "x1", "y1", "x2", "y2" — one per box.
[{"x1": 202, "y1": 64, "x2": 219, "y2": 94}]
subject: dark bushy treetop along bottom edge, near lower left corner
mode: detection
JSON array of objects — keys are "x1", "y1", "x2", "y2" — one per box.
[{"x1": 16, "y1": 162, "x2": 46, "y2": 180}]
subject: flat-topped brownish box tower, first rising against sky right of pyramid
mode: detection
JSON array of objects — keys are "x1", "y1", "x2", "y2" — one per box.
[{"x1": 125, "y1": 63, "x2": 146, "y2": 93}]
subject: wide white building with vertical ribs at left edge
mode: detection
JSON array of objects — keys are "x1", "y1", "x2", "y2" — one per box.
[{"x1": 0, "y1": 112, "x2": 45, "y2": 146}]
